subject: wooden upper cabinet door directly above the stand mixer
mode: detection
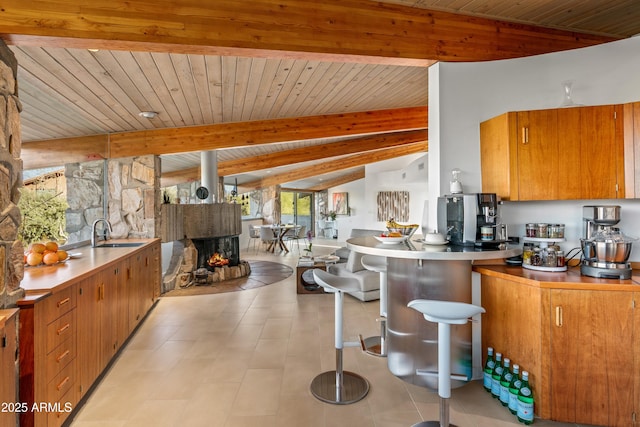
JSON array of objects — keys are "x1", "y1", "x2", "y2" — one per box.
[{"x1": 579, "y1": 105, "x2": 624, "y2": 199}]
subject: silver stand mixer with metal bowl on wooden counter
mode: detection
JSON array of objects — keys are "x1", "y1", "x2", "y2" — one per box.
[{"x1": 580, "y1": 206, "x2": 634, "y2": 279}]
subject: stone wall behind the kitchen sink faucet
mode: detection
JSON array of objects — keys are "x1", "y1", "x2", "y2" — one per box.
[{"x1": 65, "y1": 155, "x2": 161, "y2": 243}]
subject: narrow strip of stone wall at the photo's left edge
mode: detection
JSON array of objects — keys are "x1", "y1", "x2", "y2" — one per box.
[{"x1": 0, "y1": 41, "x2": 24, "y2": 308}]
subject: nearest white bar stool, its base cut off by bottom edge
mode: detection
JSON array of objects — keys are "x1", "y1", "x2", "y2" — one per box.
[{"x1": 407, "y1": 299, "x2": 485, "y2": 427}]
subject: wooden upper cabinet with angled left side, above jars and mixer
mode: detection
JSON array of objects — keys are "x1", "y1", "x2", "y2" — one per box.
[{"x1": 480, "y1": 104, "x2": 624, "y2": 200}]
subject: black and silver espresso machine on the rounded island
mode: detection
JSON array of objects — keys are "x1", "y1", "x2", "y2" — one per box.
[{"x1": 438, "y1": 193, "x2": 506, "y2": 247}]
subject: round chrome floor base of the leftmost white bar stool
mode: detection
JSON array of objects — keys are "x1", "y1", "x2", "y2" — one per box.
[{"x1": 311, "y1": 371, "x2": 369, "y2": 405}]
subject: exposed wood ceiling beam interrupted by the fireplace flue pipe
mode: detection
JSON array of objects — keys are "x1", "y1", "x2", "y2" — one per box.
[{"x1": 161, "y1": 130, "x2": 428, "y2": 187}]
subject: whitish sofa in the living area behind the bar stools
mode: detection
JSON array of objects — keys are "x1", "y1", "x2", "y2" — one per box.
[{"x1": 327, "y1": 228, "x2": 382, "y2": 301}]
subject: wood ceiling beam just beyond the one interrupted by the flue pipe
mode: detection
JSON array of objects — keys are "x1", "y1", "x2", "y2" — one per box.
[{"x1": 241, "y1": 142, "x2": 428, "y2": 189}]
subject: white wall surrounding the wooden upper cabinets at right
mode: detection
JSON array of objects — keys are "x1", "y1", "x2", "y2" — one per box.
[{"x1": 429, "y1": 37, "x2": 640, "y2": 261}]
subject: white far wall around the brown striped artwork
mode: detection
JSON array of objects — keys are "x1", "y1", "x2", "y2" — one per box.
[{"x1": 328, "y1": 154, "x2": 428, "y2": 240}]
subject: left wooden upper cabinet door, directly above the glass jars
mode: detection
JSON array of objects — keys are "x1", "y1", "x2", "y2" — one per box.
[{"x1": 517, "y1": 110, "x2": 559, "y2": 200}]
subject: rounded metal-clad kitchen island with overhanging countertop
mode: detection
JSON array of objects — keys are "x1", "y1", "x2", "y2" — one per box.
[{"x1": 347, "y1": 236, "x2": 521, "y2": 390}]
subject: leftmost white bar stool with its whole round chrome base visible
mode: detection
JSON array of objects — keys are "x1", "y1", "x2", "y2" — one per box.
[{"x1": 311, "y1": 268, "x2": 369, "y2": 405}]
